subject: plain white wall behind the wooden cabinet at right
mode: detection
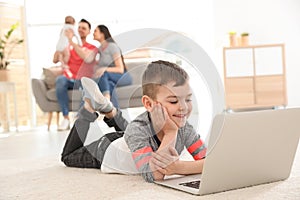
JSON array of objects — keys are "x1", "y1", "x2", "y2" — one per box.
[{"x1": 214, "y1": 0, "x2": 300, "y2": 106}]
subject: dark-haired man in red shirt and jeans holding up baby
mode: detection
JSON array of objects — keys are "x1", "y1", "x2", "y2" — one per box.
[{"x1": 53, "y1": 19, "x2": 97, "y2": 131}]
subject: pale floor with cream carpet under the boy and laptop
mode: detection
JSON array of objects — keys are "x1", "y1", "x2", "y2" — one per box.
[{"x1": 0, "y1": 109, "x2": 300, "y2": 200}]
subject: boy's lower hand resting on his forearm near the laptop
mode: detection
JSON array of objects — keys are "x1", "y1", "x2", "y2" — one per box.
[{"x1": 151, "y1": 147, "x2": 179, "y2": 175}]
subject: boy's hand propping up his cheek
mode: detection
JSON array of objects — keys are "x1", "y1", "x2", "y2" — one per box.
[{"x1": 150, "y1": 103, "x2": 178, "y2": 134}]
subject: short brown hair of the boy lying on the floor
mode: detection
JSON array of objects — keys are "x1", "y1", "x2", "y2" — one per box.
[{"x1": 142, "y1": 60, "x2": 189, "y2": 99}]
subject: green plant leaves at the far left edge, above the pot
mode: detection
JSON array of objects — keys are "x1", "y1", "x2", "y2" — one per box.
[{"x1": 0, "y1": 22, "x2": 24, "y2": 70}]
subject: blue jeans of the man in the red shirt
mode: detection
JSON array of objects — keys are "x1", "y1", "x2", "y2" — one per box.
[{"x1": 55, "y1": 75, "x2": 81, "y2": 116}]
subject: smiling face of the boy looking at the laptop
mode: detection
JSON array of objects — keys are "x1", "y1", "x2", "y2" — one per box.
[{"x1": 156, "y1": 81, "x2": 192, "y2": 127}]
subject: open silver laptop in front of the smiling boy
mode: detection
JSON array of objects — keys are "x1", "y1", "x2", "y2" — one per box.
[{"x1": 155, "y1": 108, "x2": 300, "y2": 195}]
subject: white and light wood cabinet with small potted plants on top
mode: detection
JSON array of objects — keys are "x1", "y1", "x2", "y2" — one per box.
[{"x1": 223, "y1": 44, "x2": 287, "y2": 110}]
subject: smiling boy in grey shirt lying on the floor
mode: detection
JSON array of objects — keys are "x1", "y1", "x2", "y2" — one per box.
[{"x1": 62, "y1": 60, "x2": 206, "y2": 182}]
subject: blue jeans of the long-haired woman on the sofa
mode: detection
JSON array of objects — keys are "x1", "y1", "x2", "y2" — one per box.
[{"x1": 95, "y1": 72, "x2": 132, "y2": 108}]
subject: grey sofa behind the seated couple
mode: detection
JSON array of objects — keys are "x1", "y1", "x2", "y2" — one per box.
[{"x1": 31, "y1": 59, "x2": 149, "y2": 130}]
